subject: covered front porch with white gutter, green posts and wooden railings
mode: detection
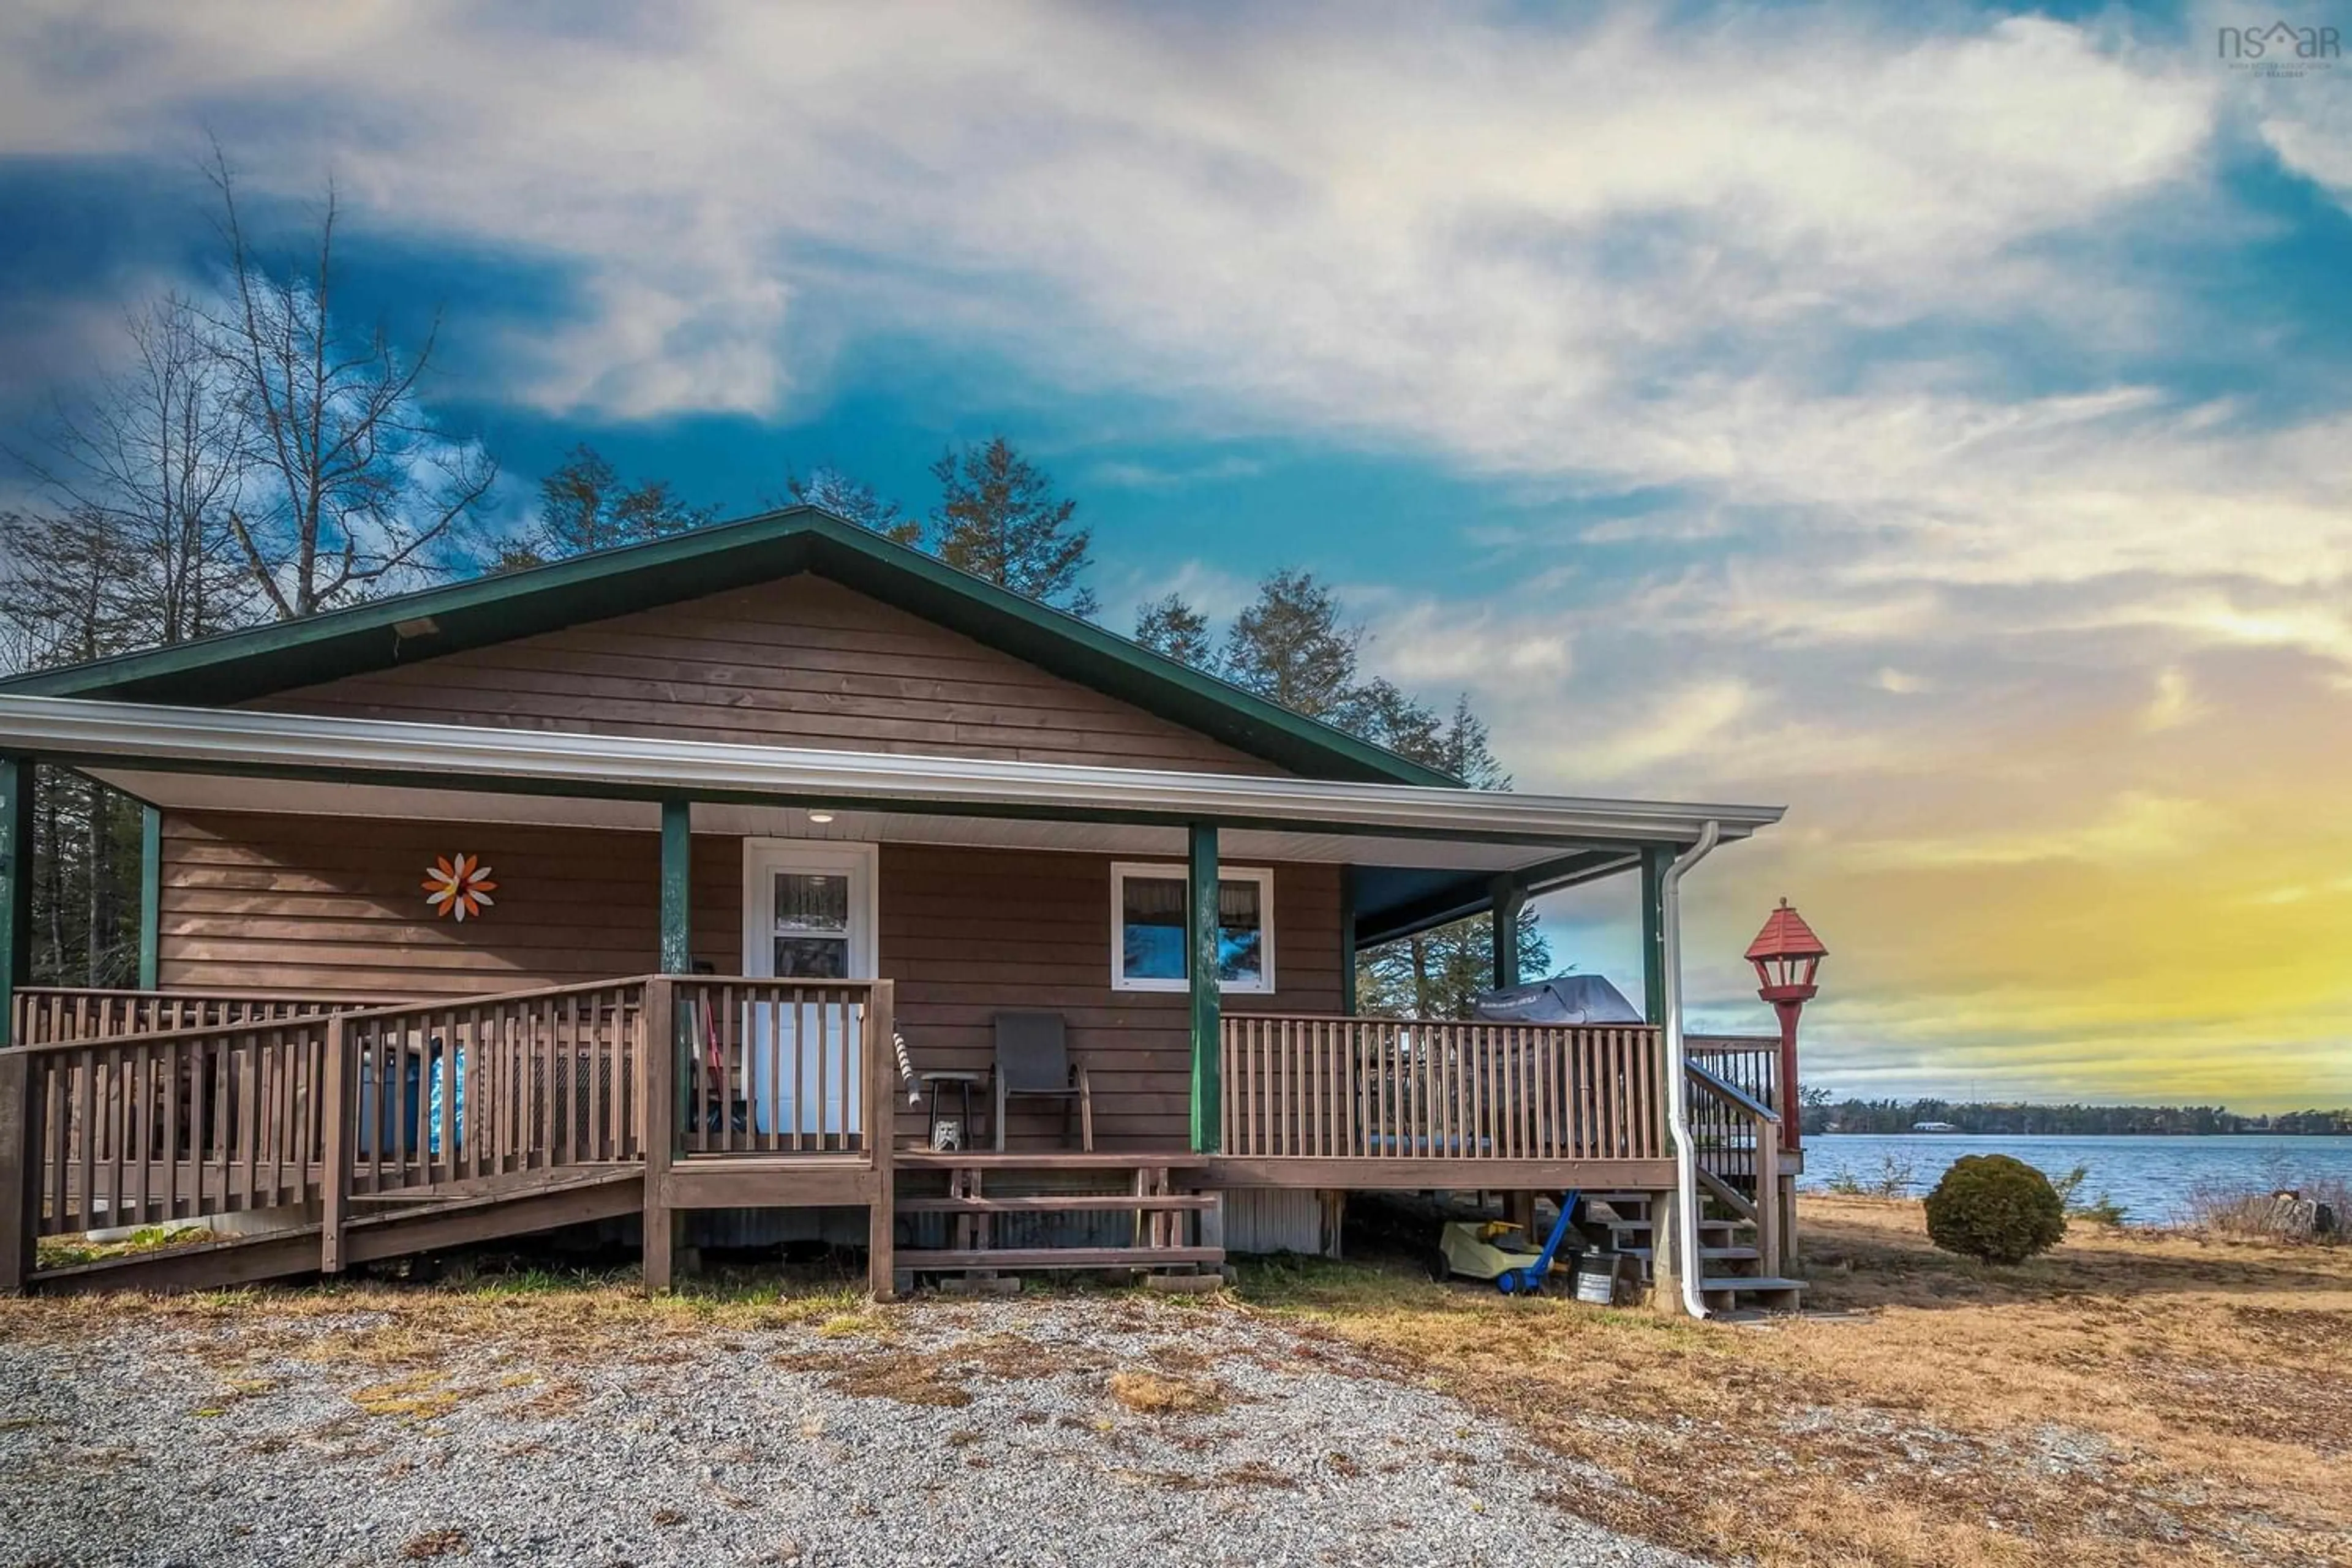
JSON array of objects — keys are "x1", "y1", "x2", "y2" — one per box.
[{"x1": 0, "y1": 696, "x2": 1778, "y2": 1293}]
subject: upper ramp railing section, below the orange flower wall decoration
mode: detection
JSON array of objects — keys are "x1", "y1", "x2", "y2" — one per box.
[{"x1": 334, "y1": 978, "x2": 647, "y2": 1194}]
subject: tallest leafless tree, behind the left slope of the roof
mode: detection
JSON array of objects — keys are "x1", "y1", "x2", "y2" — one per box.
[{"x1": 207, "y1": 146, "x2": 499, "y2": 620}]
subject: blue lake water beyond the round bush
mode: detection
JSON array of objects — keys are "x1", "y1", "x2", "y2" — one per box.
[{"x1": 1797, "y1": 1133, "x2": 2352, "y2": 1225}]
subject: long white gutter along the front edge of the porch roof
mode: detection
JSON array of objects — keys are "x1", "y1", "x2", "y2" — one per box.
[{"x1": 0, "y1": 696, "x2": 1781, "y2": 844}]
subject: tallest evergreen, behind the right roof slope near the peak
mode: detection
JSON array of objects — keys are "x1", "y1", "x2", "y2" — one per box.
[{"x1": 932, "y1": 435, "x2": 1096, "y2": 616}]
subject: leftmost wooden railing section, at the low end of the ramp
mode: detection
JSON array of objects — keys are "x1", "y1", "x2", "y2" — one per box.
[{"x1": 0, "y1": 1013, "x2": 330, "y2": 1237}]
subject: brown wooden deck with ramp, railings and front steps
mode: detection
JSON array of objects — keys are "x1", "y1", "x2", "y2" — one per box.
[{"x1": 0, "y1": 976, "x2": 1785, "y2": 1295}]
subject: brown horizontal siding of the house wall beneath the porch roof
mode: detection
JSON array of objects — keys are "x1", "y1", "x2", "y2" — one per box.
[{"x1": 160, "y1": 813, "x2": 1343, "y2": 1147}]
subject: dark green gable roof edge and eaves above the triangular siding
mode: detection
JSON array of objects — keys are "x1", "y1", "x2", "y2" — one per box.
[{"x1": 0, "y1": 505, "x2": 1458, "y2": 785}]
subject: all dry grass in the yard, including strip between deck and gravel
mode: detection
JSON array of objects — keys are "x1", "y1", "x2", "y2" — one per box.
[{"x1": 0, "y1": 1199, "x2": 2352, "y2": 1568}]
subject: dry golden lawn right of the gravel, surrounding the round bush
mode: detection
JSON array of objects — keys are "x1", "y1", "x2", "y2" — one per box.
[{"x1": 1249, "y1": 1197, "x2": 2352, "y2": 1568}]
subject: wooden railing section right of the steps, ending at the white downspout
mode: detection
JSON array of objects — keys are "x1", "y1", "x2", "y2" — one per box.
[{"x1": 1221, "y1": 1016, "x2": 1668, "y2": 1159}]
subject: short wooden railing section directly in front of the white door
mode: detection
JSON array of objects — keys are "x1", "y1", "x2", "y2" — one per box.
[{"x1": 670, "y1": 976, "x2": 899, "y2": 1154}]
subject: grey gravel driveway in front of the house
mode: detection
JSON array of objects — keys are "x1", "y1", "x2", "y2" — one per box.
[{"x1": 0, "y1": 1298, "x2": 1691, "y2": 1568}]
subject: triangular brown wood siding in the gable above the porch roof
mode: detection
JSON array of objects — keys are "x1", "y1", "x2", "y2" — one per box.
[{"x1": 254, "y1": 576, "x2": 1282, "y2": 774}]
